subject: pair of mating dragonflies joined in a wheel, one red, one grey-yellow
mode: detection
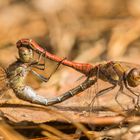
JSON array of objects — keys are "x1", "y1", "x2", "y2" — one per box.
[{"x1": 0, "y1": 39, "x2": 140, "y2": 110}]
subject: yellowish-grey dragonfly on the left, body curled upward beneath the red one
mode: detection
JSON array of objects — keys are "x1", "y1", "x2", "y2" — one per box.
[{"x1": 0, "y1": 41, "x2": 95, "y2": 106}]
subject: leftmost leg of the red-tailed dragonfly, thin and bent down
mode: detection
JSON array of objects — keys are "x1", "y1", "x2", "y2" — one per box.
[{"x1": 89, "y1": 85, "x2": 116, "y2": 112}]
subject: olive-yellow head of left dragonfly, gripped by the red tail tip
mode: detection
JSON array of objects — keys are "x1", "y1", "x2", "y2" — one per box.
[{"x1": 18, "y1": 46, "x2": 33, "y2": 63}]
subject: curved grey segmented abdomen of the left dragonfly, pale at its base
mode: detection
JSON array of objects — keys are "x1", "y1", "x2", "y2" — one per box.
[{"x1": 15, "y1": 79, "x2": 97, "y2": 106}]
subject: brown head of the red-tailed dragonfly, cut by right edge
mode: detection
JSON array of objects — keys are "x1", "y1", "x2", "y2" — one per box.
[{"x1": 126, "y1": 68, "x2": 140, "y2": 87}]
